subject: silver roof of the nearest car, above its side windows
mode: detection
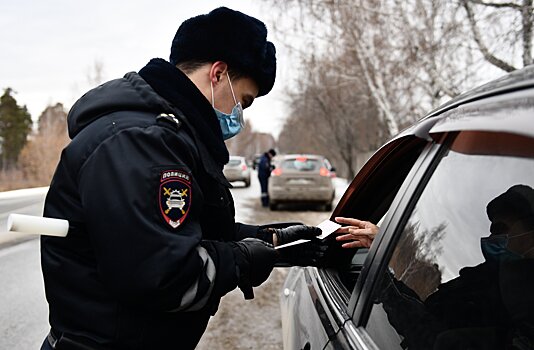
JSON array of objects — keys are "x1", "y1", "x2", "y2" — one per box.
[{"x1": 398, "y1": 65, "x2": 534, "y2": 141}]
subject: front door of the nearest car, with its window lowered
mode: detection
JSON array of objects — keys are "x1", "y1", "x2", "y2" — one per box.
[{"x1": 281, "y1": 127, "x2": 436, "y2": 349}]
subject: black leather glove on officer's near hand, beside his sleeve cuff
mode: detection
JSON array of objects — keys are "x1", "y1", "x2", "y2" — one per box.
[{"x1": 232, "y1": 238, "x2": 278, "y2": 299}]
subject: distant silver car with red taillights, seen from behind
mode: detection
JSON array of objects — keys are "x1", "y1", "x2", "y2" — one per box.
[{"x1": 268, "y1": 154, "x2": 335, "y2": 211}]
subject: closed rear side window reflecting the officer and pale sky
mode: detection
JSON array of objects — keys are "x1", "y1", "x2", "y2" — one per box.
[{"x1": 365, "y1": 131, "x2": 534, "y2": 349}]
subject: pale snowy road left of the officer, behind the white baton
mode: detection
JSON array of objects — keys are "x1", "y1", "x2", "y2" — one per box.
[{"x1": 0, "y1": 189, "x2": 48, "y2": 349}]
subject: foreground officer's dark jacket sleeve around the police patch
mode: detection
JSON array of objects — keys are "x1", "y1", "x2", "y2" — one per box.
[{"x1": 78, "y1": 126, "x2": 238, "y2": 311}]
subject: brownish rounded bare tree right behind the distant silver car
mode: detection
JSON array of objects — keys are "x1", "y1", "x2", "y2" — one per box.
[{"x1": 279, "y1": 56, "x2": 386, "y2": 178}]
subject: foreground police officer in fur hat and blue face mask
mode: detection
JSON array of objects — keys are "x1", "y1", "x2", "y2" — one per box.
[{"x1": 41, "y1": 8, "x2": 320, "y2": 350}]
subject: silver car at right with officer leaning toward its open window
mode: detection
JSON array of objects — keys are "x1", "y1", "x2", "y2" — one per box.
[{"x1": 281, "y1": 67, "x2": 534, "y2": 349}]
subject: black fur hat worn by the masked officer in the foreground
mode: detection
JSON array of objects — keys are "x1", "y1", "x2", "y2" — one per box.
[{"x1": 170, "y1": 7, "x2": 276, "y2": 96}]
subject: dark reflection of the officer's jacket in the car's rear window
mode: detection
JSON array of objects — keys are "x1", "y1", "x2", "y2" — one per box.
[{"x1": 377, "y1": 259, "x2": 534, "y2": 350}]
